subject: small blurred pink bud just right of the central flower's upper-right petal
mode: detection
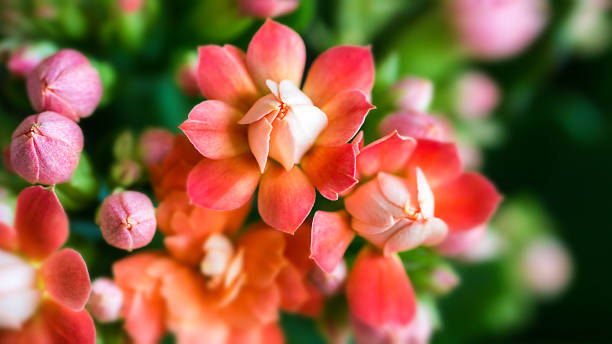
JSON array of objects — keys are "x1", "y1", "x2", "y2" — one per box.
[{"x1": 392, "y1": 77, "x2": 433, "y2": 112}]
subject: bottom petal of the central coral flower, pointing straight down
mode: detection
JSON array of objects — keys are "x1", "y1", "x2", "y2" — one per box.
[{"x1": 258, "y1": 164, "x2": 316, "y2": 233}]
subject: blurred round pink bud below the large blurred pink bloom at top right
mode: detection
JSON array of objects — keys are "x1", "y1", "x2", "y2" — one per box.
[{"x1": 455, "y1": 72, "x2": 499, "y2": 118}]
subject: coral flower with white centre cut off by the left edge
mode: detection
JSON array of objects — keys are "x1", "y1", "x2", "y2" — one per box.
[{"x1": 0, "y1": 186, "x2": 95, "y2": 344}]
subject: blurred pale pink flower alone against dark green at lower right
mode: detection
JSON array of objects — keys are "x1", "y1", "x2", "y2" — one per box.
[{"x1": 521, "y1": 238, "x2": 572, "y2": 297}]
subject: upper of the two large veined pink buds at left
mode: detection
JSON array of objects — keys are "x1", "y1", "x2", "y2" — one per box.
[{"x1": 27, "y1": 49, "x2": 102, "y2": 121}]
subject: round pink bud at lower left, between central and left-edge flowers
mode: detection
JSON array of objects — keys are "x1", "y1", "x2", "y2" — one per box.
[{"x1": 100, "y1": 191, "x2": 157, "y2": 251}]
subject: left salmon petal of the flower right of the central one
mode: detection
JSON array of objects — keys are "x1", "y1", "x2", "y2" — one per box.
[{"x1": 310, "y1": 211, "x2": 355, "y2": 273}]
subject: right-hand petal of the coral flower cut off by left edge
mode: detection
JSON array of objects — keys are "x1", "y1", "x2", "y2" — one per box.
[{"x1": 41, "y1": 248, "x2": 91, "y2": 311}]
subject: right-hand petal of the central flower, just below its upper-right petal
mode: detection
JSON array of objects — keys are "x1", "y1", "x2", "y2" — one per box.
[{"x1": 317, "y1": 90, "x2": 375, "y2": 145}]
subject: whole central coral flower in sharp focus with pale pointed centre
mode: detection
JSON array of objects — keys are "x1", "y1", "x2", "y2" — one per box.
[{"x1": 180, "y1": 20, "x2": 374, "y2": 233}]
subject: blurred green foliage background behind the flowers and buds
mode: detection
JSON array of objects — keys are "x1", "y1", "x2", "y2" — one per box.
[{"x1": 0, "y1": 0, "x2": 612, "y2": 343}]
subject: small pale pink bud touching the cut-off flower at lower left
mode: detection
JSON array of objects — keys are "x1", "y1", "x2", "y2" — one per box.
[{"x1": 87, "y1": 277, "x2": 123, "y2": 323}]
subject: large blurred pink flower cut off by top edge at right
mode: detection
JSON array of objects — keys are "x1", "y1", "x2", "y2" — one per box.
[{"x1": 449, "y1": 0, "x2": 548, "y2": 60}]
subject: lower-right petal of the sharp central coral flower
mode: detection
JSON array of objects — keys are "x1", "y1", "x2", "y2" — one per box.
[{"x1": 301, "y1": 143, "x2": 358, "y2": 201}]
